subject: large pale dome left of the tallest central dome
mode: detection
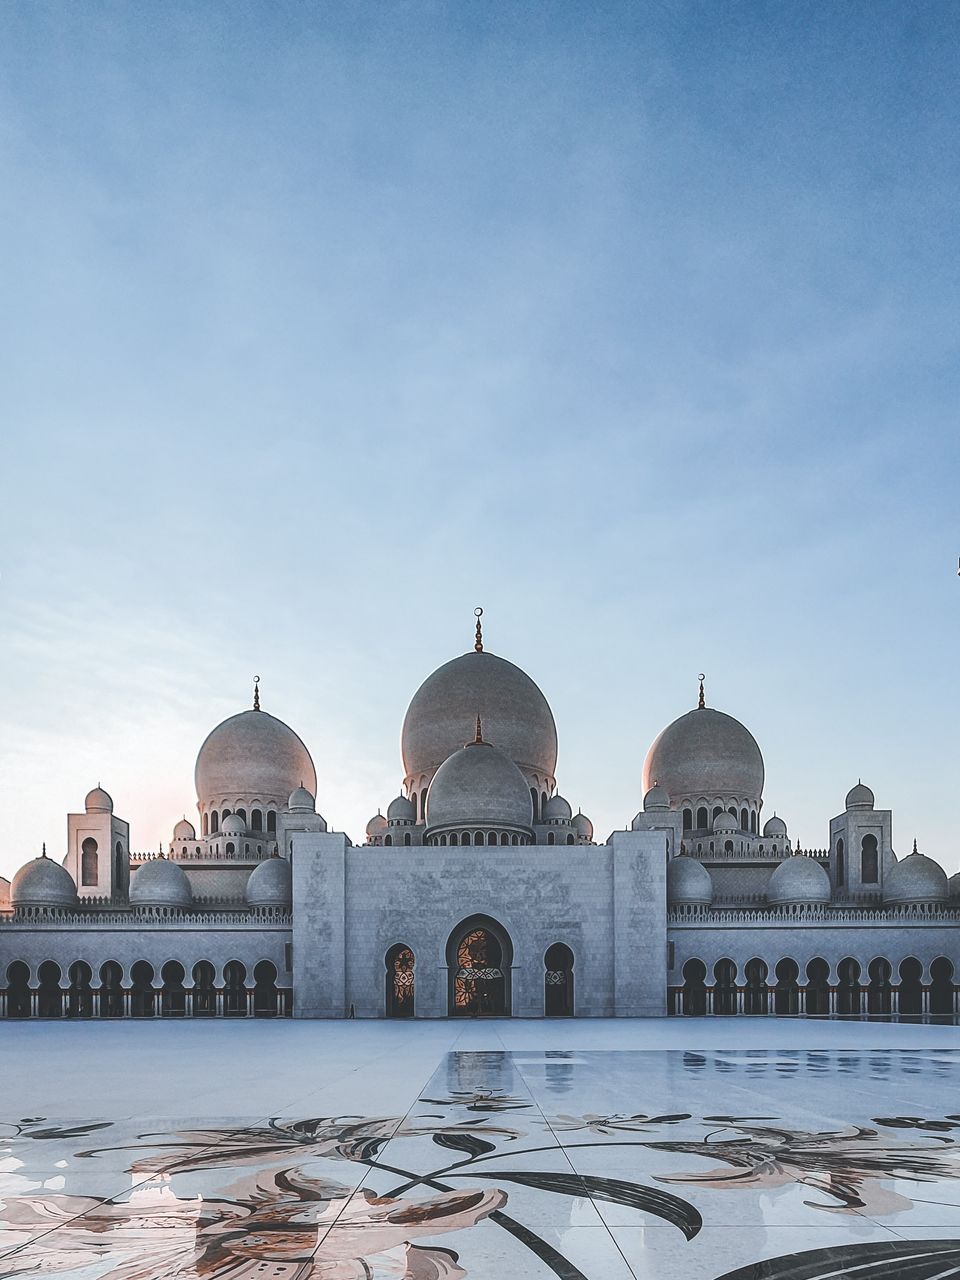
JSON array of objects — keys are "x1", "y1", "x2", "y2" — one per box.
[{"x1": 193, "y1": 710, "x2": 316, "y2": 809}]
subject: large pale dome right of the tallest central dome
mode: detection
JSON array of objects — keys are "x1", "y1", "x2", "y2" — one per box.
[{"x1": 643, "y1": 707, "x2": 763, "y2": 808}]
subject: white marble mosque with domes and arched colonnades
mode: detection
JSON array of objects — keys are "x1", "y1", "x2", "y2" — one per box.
[{"x1": 0, "y1": 611, "x2": 960, "y2": 1021}]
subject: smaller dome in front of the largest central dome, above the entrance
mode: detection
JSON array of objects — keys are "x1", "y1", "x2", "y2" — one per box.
[{"x1": 426, "y1": 741, "x2": 534, "y2": 835}]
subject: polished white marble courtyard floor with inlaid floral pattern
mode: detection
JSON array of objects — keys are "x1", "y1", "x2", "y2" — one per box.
[{"x1": 0, "y1": 1019, "x2": 960, "y2": 1280}]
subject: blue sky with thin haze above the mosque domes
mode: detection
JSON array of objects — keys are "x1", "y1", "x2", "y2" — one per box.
[{"x1": 0, "y1": 0, "x2": 960, "y2": 874}]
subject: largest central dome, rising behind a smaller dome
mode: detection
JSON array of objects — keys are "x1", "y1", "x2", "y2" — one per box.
[{"x1": 401, "y1": 652, "x2": 557, "y2": 780}]
